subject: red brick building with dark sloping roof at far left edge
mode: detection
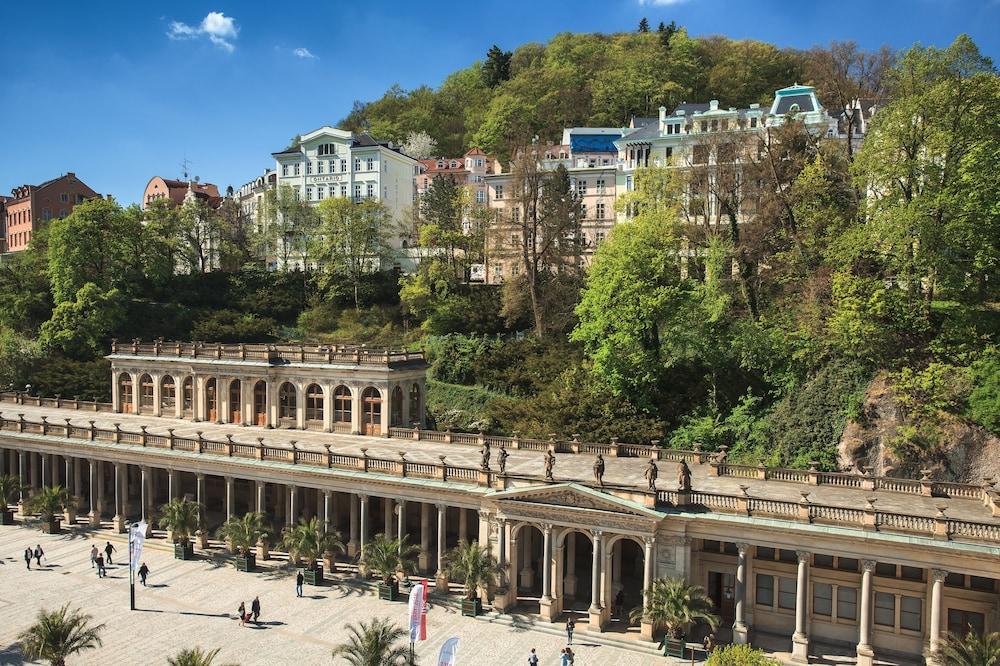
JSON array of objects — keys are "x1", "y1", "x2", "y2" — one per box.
[{"x1": 0, "y1": 171, "x2": 100, "y2": 252}]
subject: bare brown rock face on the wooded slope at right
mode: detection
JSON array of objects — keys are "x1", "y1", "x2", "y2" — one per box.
[{"x1": 837, "y1": 374, "x2": 1000, "y2": 483}]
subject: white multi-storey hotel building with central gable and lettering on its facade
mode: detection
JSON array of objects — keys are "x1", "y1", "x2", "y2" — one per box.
[{"x1": 272, "y1": 126, "x2": 420, "y2": 270}]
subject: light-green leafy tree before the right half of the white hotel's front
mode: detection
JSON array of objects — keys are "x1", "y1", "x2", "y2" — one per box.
[{"x1": 310, "y1": 197, "x2": 392, "y2": 309}]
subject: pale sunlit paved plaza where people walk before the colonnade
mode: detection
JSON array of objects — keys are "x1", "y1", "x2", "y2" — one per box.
[{"x1": 0, "y1": 527, "x2": 664, "y2": 666}]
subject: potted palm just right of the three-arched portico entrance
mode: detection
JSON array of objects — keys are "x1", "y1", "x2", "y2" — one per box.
[{"x1": 629, "y1": 578, "x2": 719, "y2": 656}]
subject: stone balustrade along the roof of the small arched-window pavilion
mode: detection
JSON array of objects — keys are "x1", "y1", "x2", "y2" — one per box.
[{"x1": 111, "y1": 341, "x2": 425, "y2": 367}]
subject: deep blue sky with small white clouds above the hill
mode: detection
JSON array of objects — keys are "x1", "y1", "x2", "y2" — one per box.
[{"x1": 0, "y1": 0, "x2": 1000, "y2": 203}]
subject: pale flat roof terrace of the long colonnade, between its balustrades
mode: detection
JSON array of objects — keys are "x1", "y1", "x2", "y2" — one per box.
[{"x1": 0, "y1": 403, "x2": 1000, "y2": 523}]
